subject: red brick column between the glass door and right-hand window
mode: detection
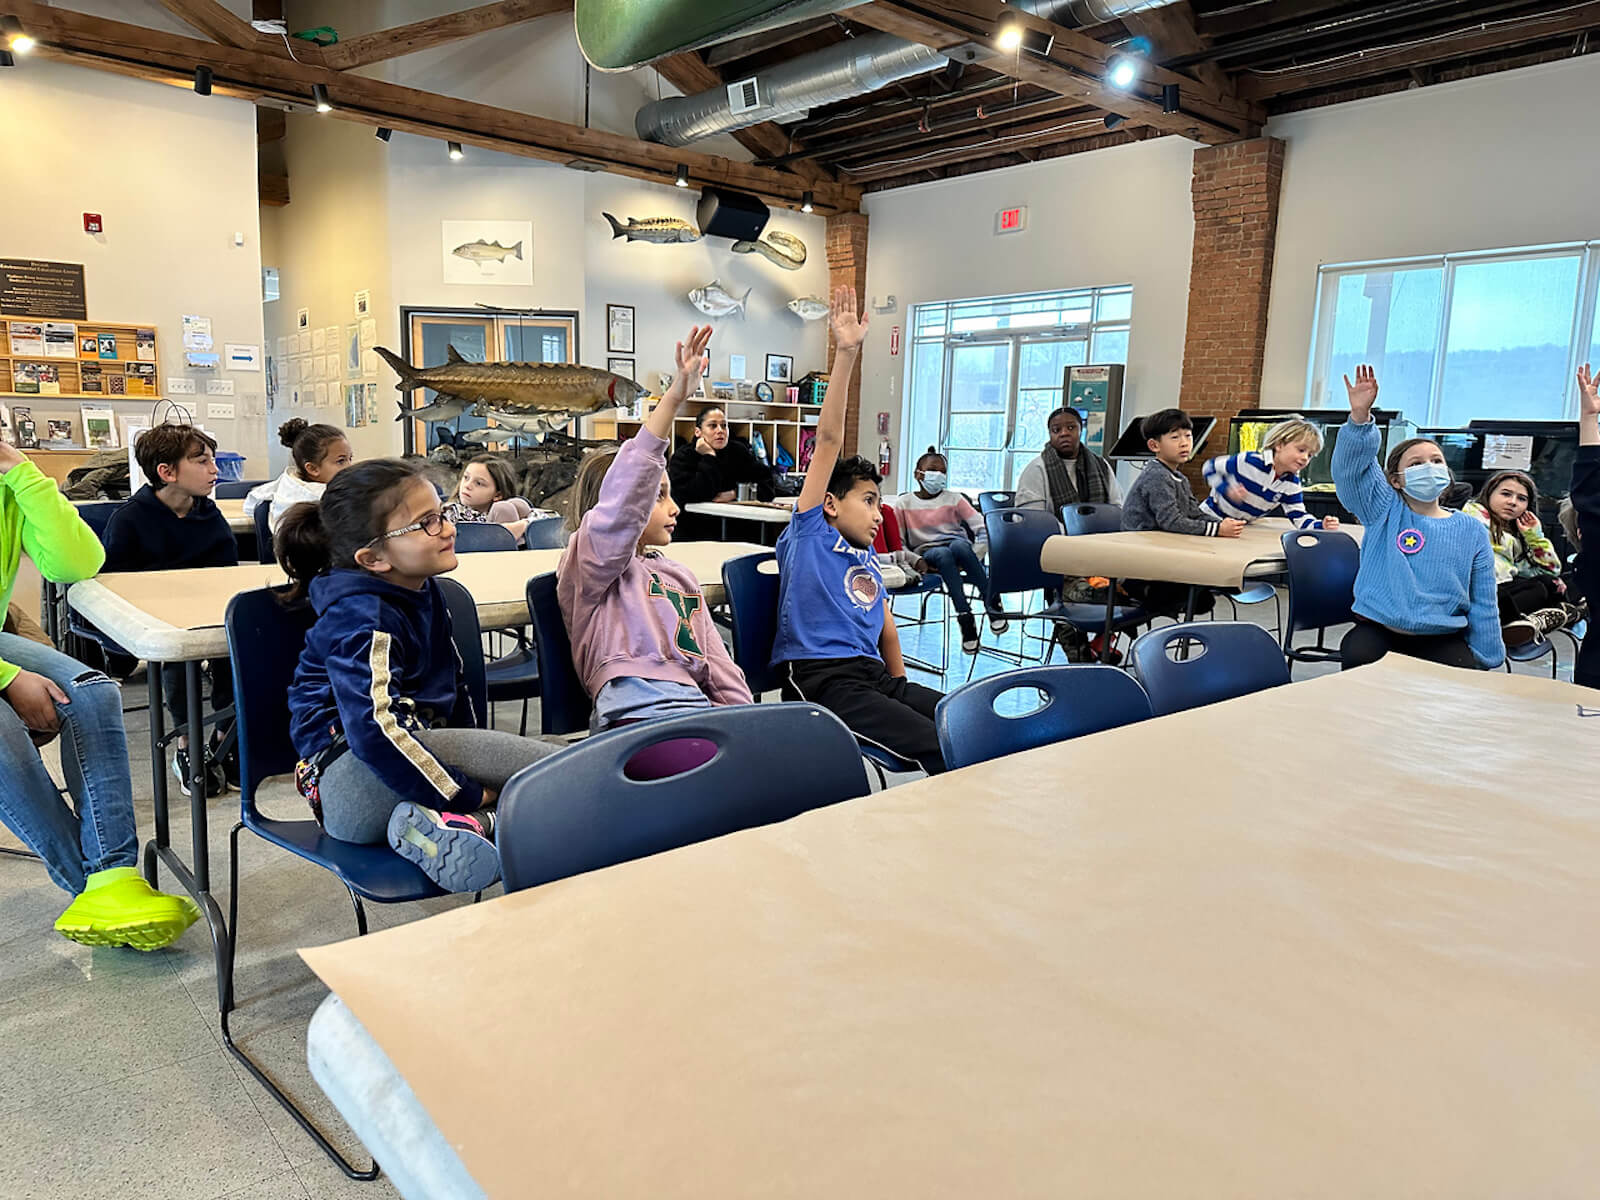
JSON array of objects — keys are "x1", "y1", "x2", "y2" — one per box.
[{"x1": 1178, "y1": 138, "x2": 1283, "y2": 496}]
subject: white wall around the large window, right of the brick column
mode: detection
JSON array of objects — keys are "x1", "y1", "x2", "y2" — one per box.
[{"x1": 1261, "y1": 59, "x2": 1600, "y2": 405}]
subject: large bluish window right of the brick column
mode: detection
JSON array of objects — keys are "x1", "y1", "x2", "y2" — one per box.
[{"x1": 1306, "y1": 242, "x2": 1600, "y2": 427}]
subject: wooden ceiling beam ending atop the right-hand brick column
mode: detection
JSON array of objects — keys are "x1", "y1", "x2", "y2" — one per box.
[{"x1": 846, "y1": 0, "x2": 1264, "y2": 144}]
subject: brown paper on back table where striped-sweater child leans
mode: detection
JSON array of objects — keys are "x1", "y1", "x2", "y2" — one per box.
[{"x1": 1038, "y1": 518, "x2": 1365, "y2": 589}]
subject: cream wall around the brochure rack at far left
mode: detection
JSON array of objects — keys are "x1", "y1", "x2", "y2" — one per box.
[{"x1": 0, "y1": 58, "x2": 266, "y2": 472}]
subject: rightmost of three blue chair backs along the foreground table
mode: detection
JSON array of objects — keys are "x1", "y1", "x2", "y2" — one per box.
[{"x1": 1128, "y1": 621, "x2": 1290, "y2": 717}]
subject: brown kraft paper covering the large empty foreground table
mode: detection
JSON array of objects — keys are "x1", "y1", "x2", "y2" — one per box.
[{"x1": 302, "y1": 656, "x2": 1600, "y2": 1200}]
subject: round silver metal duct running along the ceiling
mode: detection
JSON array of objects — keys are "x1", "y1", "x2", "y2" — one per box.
[{"x1": 634, "y1": 0, "x2": 1171, "y2": 146}]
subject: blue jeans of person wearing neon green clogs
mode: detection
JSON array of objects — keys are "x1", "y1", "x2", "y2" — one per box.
[{"x1": 0, "y1": 634, "x2": 139, "y2": 896}]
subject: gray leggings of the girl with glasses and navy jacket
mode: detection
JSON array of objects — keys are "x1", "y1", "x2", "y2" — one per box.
[{"x1": 318, "y1": 730, "x2": 563, "y2": 845}]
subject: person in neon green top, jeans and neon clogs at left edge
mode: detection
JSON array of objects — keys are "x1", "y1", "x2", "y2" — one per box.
[{"x1": 0, "y1": 442, "x2": 200, "y2": 950}]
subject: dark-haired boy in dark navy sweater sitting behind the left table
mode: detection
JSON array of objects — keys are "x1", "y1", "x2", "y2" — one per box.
[{"x1": 104, "y1": 426, "x2": 238, "y2": 795}]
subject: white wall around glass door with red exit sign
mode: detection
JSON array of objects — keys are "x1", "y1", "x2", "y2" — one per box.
[{"x1": 859, "y1": 138, "x2": 1194, "y2": 474}]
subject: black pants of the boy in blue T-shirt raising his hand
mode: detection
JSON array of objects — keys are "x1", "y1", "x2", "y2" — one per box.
[{"x1": 782, "y1": 658, "x2": 946, "y2": 774}]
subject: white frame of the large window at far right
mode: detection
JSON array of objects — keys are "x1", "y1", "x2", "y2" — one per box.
[{"x1": 1306, "y1": 238, "x2": 1600, "y2": 429}]
